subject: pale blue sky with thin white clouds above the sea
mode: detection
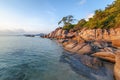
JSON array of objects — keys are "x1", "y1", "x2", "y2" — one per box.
[{"x1": 0, "y1": 0, "x2": 114, "y2": 34}]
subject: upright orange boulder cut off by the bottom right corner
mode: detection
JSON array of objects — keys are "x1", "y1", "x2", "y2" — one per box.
[{"x1": 114, "y1": 52, "x2": 120, "y2": 80}]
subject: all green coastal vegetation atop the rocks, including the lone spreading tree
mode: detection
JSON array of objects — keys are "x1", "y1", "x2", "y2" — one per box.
[{"x1": 58, "y1": 0, "x2": 120, "y2": 31}]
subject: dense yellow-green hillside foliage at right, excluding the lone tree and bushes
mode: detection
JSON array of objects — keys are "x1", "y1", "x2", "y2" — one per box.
[{"x1": 84, "y1": 0, "x2": 120, "y2": 29}]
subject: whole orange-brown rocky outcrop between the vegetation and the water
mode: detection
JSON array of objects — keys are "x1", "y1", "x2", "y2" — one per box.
[{"x1": 45, "y1": 28, "x2": 120, "y2": 80}]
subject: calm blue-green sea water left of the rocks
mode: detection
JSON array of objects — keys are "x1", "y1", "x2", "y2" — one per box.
[{"x1": 0, "y1": 36, "x2": 87, "y2": 80}]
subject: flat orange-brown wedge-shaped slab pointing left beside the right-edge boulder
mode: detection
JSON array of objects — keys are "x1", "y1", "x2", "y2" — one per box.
[{"x1": 92, "y1": 52, "x2": 115, "y2": 62}]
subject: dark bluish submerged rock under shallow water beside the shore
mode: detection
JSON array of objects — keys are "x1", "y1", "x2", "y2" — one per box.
[{"x1": 61, "y1": 52, "x2": 114, "y2": 80}]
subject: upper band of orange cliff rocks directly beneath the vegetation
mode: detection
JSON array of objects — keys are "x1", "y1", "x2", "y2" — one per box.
[{"x1": 46, "y1": 28, "x2": 120, "y2": 41}]
